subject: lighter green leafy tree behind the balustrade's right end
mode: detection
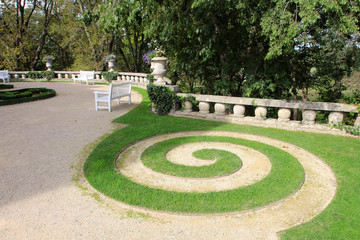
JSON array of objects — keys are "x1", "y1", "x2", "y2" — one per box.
[{"x1": 261, "y1": 0, "x2": 359, "y2": 101}]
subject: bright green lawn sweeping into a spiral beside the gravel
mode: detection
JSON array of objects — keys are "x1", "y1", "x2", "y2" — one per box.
[{"x1": 84, "y1": 89, "x2": 360, "y2": 239}]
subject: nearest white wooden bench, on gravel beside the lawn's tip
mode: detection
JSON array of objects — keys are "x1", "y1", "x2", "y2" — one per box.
[{"x1": 94, "y1": 82, "x2": 131, "y2": 112}]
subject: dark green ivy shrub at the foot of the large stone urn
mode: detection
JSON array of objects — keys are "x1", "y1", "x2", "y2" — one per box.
[{"x1": 147, "y1": 83, "x2": 181, "y2": 116}]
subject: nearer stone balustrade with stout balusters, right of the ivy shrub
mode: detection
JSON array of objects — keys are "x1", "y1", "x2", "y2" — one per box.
[{"x1": 178, "y1": 93, "x2": 360, "y2": 127}]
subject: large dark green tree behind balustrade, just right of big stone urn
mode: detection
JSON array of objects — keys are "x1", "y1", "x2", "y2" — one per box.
[{"x1": 147, "y1": 0, "x2": 260, "y2": 95}]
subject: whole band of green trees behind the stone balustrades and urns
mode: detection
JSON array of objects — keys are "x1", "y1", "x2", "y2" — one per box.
[{"x1": 0, "y1": 0, "x2": 360, "y2": 101}]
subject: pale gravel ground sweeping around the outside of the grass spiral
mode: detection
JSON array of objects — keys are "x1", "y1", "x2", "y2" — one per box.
[{"x1": 0, "y1": 82, "x2": 336, "y2": 240}]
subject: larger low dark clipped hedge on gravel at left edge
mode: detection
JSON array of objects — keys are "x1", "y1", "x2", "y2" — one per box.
[{"x1": 0, "y1": 88, "x2": 56, "y2": 106}]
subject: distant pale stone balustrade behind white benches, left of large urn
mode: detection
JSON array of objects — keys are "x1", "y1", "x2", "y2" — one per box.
[{"x1": 9, "y1": 71, "x2": 149, "y2": 86}]
